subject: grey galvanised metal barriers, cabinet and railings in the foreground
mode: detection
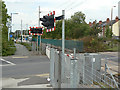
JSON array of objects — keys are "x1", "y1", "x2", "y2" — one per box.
[{"x1": 46, "y1": 47, "x2": 118, "y2": 88}]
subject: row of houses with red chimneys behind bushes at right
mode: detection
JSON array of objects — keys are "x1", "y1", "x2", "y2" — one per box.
[{"x1": 89, "y1": 16, "x2": 120, "y2": 38}]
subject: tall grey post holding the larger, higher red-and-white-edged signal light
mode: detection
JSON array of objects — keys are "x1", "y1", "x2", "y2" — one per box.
[{"x1": 40, "y1": 10, "x2": 65, "y2": 88}]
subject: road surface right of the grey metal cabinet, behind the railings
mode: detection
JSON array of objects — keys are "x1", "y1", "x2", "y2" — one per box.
[{"x1": 100, "y1": 52, "x2": 120, "y2": 75}]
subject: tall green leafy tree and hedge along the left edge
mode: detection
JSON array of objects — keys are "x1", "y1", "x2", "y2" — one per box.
[{"x1": 0, "y1": 1, "x2": 15, "y2": 55}]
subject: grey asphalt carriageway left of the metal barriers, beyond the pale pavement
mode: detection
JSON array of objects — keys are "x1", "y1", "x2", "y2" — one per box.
[{"x1": 2, "y1": 56, "x2": 49, "y2": 77}]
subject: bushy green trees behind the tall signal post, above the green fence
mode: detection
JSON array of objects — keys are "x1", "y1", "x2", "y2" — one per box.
[{"x1": 42, "y1": 12, "x2": 90, "y2": 39}]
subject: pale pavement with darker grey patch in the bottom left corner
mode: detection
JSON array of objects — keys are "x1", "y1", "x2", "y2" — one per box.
[{"x1": 0, "y1": 76, "x2": 52, "y2": 88}]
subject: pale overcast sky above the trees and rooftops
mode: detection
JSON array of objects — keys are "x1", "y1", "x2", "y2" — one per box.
[{"x1": 3, "y1": 0, "x2": 120, "y2": 31}]
